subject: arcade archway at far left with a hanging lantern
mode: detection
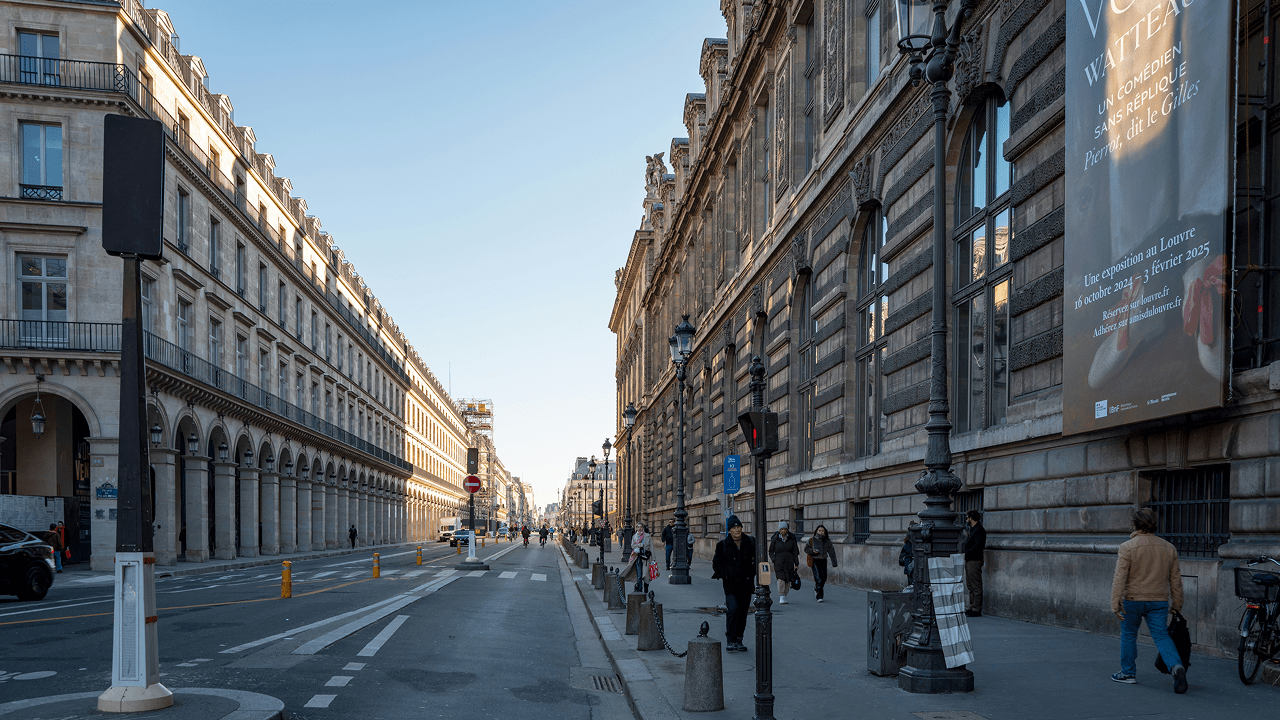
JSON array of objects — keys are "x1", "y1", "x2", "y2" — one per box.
[{"x1": 0, "y1": 392, "x2": 92, "y2": 562}]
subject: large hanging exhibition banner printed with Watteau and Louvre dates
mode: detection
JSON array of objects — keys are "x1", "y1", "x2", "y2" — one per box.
[{"x1": 1062, "y1": 0, "x2": 1235, "y2": 434}]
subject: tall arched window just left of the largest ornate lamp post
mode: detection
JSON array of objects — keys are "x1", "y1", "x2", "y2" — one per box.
[{"x1": 854, "y1": 211, "x2": 888, "y2": 457}]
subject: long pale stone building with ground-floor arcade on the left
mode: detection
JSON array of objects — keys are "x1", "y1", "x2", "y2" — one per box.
[{"x1": 0, "y1": 0, "x2": 471, "y2": 570}]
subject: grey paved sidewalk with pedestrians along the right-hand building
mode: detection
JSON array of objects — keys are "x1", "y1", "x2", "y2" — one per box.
[{"x1": 573, "y1": 543, "x2": 1280, "y2": 720}]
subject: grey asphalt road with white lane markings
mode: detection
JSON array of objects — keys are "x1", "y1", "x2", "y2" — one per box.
[{"x1": 0, "y1": 538, "x2": 625, "y2": 719}]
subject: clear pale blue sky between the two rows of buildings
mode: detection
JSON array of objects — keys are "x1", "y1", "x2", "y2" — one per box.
[{"x1": 147, "y1": 0, "x2": 724, "y2": 505}]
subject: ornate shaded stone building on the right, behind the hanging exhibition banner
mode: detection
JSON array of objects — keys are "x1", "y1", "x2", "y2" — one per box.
[{"x1": 609, "y1": 0, "x2": 1280, "y2": 652}]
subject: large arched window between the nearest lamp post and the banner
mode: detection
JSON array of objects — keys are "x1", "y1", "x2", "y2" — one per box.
[{"x1": 952, "y1": 100, "x2": 1014, "y2": 433}]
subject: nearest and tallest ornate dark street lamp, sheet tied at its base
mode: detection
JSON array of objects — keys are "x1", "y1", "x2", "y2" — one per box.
[{"x1": 897, "y1": 0, "x2": 977, "y2": 693}]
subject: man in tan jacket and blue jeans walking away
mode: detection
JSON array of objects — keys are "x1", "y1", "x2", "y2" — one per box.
[{"x1": 1111, "y1": 507, "x2": 1187, "y2": 693}]
